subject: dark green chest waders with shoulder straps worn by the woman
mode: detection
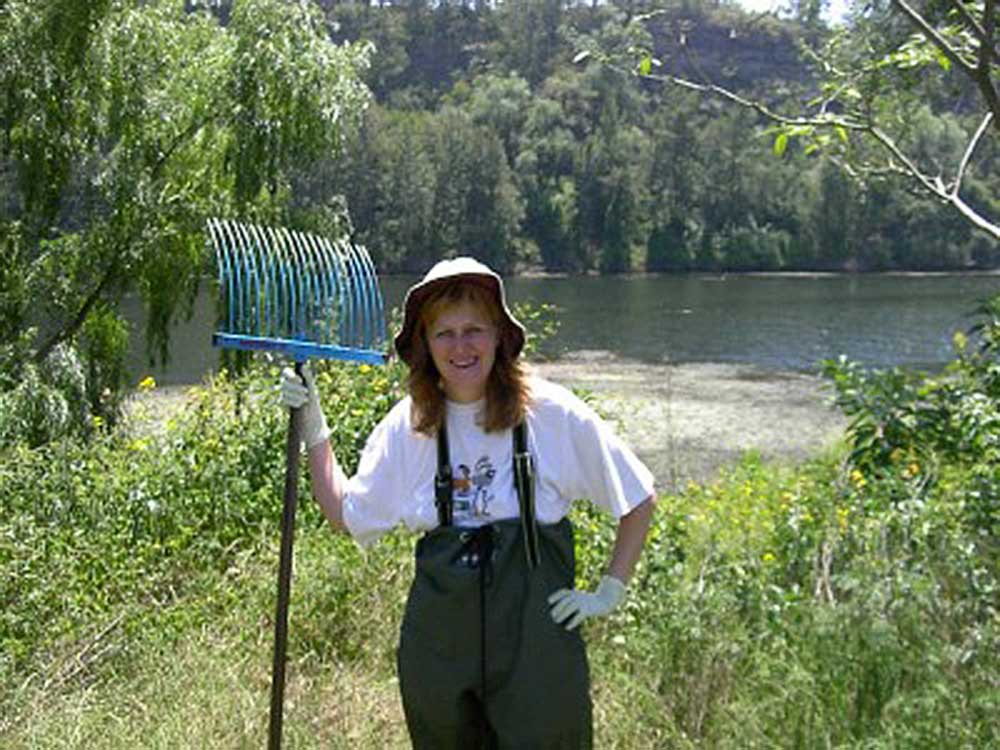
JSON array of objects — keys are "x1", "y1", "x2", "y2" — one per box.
[{"x1": 398, "y1": 432, "x2": 593, "y2": 750}]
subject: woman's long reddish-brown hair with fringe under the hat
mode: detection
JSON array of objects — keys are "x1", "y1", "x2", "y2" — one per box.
[{"x1": 407, "y1": 279, "x2": 531, "y2": 436}]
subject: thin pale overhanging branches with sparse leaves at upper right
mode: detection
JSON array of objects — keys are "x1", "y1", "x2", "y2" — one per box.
[{"x1": 600, "y1": 0, "x2": 1000, "y2": 244}]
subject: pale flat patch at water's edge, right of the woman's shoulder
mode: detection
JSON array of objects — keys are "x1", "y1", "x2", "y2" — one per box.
[{"x1": 534, "y1": 352, "x2": 845, "y2": 490}]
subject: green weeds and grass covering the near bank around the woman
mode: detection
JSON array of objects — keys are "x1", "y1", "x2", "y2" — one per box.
[{"x1": 0, "y1": 308, "x2": 1000, "y2": 750}]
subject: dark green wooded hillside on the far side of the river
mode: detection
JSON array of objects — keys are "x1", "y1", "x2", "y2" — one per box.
[{"x1": 310, "y1": 2, "x2": 997, "y2": 273}]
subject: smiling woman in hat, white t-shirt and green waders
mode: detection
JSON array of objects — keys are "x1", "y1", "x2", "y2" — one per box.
[{"x1": 282, "y1": 258, "x2": 654, "y2": 750}]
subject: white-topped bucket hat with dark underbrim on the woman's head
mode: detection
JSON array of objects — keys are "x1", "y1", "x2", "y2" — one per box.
[{"x1": 394, "y1": 257, "x2": 524, "y2": 364}]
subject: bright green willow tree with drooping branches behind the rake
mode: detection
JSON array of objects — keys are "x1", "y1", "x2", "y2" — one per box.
[{"x1": 0, "y1": 0, "x2": 368, "y2": 444}]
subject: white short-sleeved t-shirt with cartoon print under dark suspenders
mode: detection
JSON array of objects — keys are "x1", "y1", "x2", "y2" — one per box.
[{"x1": 344, "y1": 378, "x2": 653, "y2": 545}]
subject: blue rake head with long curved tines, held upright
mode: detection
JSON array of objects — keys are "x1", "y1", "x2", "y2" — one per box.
[{"x1": 208, "y1": 219, "x2": 386, "y2": 364}]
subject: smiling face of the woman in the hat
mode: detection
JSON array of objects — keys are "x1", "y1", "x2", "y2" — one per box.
[{"x1": 427, "y1": 300, "x2": 497, "y2": 403}]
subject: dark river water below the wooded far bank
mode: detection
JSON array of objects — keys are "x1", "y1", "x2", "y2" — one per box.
[{"x1": 126, "y1": 274, "x2": 1000, "y2": 384}]
